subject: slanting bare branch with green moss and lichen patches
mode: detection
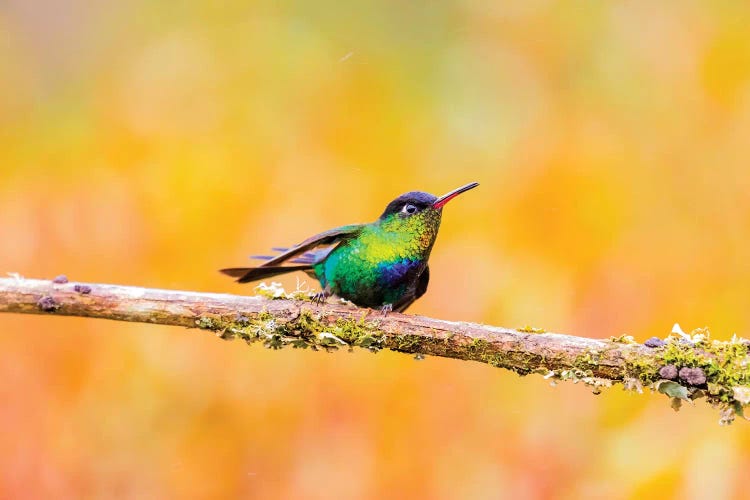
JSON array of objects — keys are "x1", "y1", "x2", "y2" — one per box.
[{"x1": 0, "y1": 276, "x2": 750, "y2": 423}]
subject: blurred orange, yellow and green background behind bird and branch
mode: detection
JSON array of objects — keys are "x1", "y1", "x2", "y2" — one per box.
[{"x1": 0, "y1": 0, "x2": 750, "y2": 499}]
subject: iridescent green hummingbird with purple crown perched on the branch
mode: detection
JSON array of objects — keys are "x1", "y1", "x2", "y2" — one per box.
[{"x1": 221, "y1": 182, "x2": 479, "y2": 314}]
